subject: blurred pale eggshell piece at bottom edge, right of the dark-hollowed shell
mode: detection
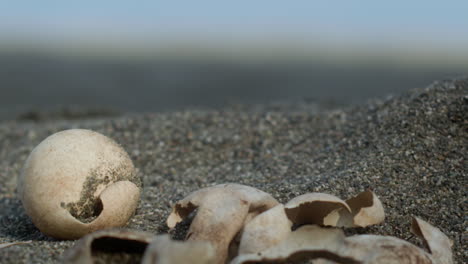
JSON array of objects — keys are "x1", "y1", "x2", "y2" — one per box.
[{"x1": 141, "y1": 235, "x2": 216, "y2": 264}]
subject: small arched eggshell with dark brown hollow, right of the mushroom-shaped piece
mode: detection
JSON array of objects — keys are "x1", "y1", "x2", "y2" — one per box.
[{"x1": 284, "y1": 193, "x2": 351, "y2": 226}]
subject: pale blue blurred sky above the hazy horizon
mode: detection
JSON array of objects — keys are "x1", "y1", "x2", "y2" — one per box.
[{"x1": 0, "y1": 0, "x2": 468, "y2": 51}]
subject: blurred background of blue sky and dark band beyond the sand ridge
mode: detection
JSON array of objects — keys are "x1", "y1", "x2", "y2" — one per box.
[{"x1": 0, "y1": 0, "x2": 468, "y2": 119}]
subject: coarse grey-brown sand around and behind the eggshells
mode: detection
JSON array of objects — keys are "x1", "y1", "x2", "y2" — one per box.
[{"x1": 0, "y1": 79, "x2": 468, "y2": 263}]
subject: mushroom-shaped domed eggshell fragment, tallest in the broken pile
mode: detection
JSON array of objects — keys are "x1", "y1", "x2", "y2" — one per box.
[{"x1": 167, "y1": 184, "x2": 278, "y2": 263}]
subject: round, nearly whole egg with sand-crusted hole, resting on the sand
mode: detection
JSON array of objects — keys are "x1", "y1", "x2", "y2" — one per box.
[{"x1": 18, "y1": 129, "x2": 141, "y2": 239}]
